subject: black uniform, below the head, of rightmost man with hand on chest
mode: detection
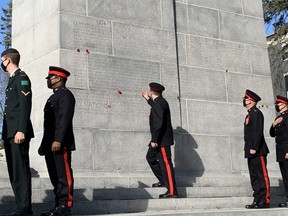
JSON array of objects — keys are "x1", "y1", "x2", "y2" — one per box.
[{"x1": 270, "y1": 111, "x2": 288, "y2": 201}]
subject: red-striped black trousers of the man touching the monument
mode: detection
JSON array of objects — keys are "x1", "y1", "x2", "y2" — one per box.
[{"x1": 146, "y1": 146, "x2": 176, "y2": 195}]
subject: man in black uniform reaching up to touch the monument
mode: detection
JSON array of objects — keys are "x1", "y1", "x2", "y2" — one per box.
[{"x1": 142, "y1": 83, "x2": 178, "y2": 198}]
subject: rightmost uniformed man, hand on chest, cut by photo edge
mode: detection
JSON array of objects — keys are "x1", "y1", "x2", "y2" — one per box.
[{"x1": 270, "y1": 96, "x2": 288, "y2": 207}]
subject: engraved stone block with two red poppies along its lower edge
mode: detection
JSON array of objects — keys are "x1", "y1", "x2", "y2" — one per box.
[{"x1": 60, "y1": 14, "x2": 112, "y2": 54}]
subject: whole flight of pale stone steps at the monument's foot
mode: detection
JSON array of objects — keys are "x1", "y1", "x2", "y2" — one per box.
[{"x1": 0, "y1": 171, "x2": 287, "y2": 216}]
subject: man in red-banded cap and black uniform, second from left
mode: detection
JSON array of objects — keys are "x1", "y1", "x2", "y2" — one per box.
[{"x1": 38, "y1": 66, "x2": 75, "y2": 216}]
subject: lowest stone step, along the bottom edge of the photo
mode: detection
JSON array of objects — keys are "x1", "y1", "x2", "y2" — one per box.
[{"x1": 0, "y1": 197, "x2": 288, "y2": 216}]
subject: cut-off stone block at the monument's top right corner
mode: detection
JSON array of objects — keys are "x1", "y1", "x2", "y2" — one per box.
[{"x1": 243, "y1": 0, "x2": 263, "y2": 18}]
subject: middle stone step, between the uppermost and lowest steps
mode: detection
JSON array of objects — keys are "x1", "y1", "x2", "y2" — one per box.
[{"x1": 0, "y1": 187, "x2": 284, "y2": 203}]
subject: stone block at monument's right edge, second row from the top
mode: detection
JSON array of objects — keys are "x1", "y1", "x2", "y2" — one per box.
[{"x1": 219, "y1": 12, "x2": 266, "y2": 45}]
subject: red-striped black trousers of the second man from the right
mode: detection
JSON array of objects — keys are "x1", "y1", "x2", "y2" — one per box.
[{"x1": 248, "y1": 155, "x2": 270, "y2": 204}]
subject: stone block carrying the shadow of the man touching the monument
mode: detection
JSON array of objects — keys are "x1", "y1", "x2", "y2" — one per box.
[{"x1": 174, "y1": 133, "x2": 231, "y2": 172}]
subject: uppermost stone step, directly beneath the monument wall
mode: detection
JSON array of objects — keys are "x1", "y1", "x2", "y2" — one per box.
[{"x1": 0, "y1": 174, "x2": 283, "y2": 189}]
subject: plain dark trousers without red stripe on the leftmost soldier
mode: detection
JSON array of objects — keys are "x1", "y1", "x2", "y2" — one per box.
[{"x1": 4, "y1": 138, "x2": 32, "y2": 214}]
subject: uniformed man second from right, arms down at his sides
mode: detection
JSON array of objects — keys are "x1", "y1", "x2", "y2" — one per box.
[{"x1": 243, "y1": 90, "x2": 270, "y2": 209}]
